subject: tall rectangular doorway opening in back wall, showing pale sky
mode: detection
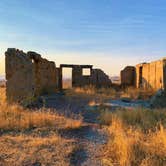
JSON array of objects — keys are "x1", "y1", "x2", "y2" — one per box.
[{"x1": 62, "y1": 67, "x2": 72, "y2": 89}]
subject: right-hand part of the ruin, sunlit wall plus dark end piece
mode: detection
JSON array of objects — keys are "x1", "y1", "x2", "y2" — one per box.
[{"x1": 121, "y1": 59, "x2": 166, "y2": 90}]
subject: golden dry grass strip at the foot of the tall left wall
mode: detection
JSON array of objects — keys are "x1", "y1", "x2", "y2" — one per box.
[{"x1": 0, "y1": 88, "x2": 82, "y2": 130}]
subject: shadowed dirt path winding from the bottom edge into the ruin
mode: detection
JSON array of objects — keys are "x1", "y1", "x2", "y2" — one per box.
[{"x1": 41, "y1": 95, "x2": 107, "y2": 166}]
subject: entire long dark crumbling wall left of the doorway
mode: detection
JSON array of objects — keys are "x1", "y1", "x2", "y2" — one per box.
[{"x1": 5, "y1": 48, "x2": 57, "y2": 102}]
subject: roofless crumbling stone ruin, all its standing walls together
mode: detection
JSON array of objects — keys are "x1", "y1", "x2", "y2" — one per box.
[{"x1": 5, "y1": 48, "x2": 166, "y2": 102}]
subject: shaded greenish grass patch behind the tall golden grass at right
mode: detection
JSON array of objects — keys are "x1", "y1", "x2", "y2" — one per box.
[{"x1": 99, "y1": 109, "x2": 166, "y2": 132}]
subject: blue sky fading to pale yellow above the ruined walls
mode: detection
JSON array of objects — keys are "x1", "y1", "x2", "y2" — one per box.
[{"x1": 0, "y1": 0, "x2": 166, "y2": 76}]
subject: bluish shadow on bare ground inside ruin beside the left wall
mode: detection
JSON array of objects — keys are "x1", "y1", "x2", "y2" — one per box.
[{"x1": 42, "y1": 94, "x2": 102, "y2": 123}]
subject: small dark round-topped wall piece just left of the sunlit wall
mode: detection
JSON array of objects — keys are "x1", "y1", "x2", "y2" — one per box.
[{"x1": 120, "y1": 66, "x2": 136, "y2": 87}]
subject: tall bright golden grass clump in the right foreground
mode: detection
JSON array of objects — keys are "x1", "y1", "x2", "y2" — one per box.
[{"x1": 103, "y1": 118, "x2": 166, "y2": 166}]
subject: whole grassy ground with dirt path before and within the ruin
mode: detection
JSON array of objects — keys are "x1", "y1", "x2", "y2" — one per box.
[{"x1": 0, "y1": 88, "x2": 166, "y2": 166}]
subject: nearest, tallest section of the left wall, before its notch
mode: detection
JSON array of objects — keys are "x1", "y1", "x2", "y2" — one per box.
[{"x1": 5, "y1": 49, "x2": 35, "y2": 102}]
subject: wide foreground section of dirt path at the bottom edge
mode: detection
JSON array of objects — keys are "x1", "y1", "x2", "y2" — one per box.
[{"x1": 61, "y1": 124, "x2": 107, "y2": 166}]
